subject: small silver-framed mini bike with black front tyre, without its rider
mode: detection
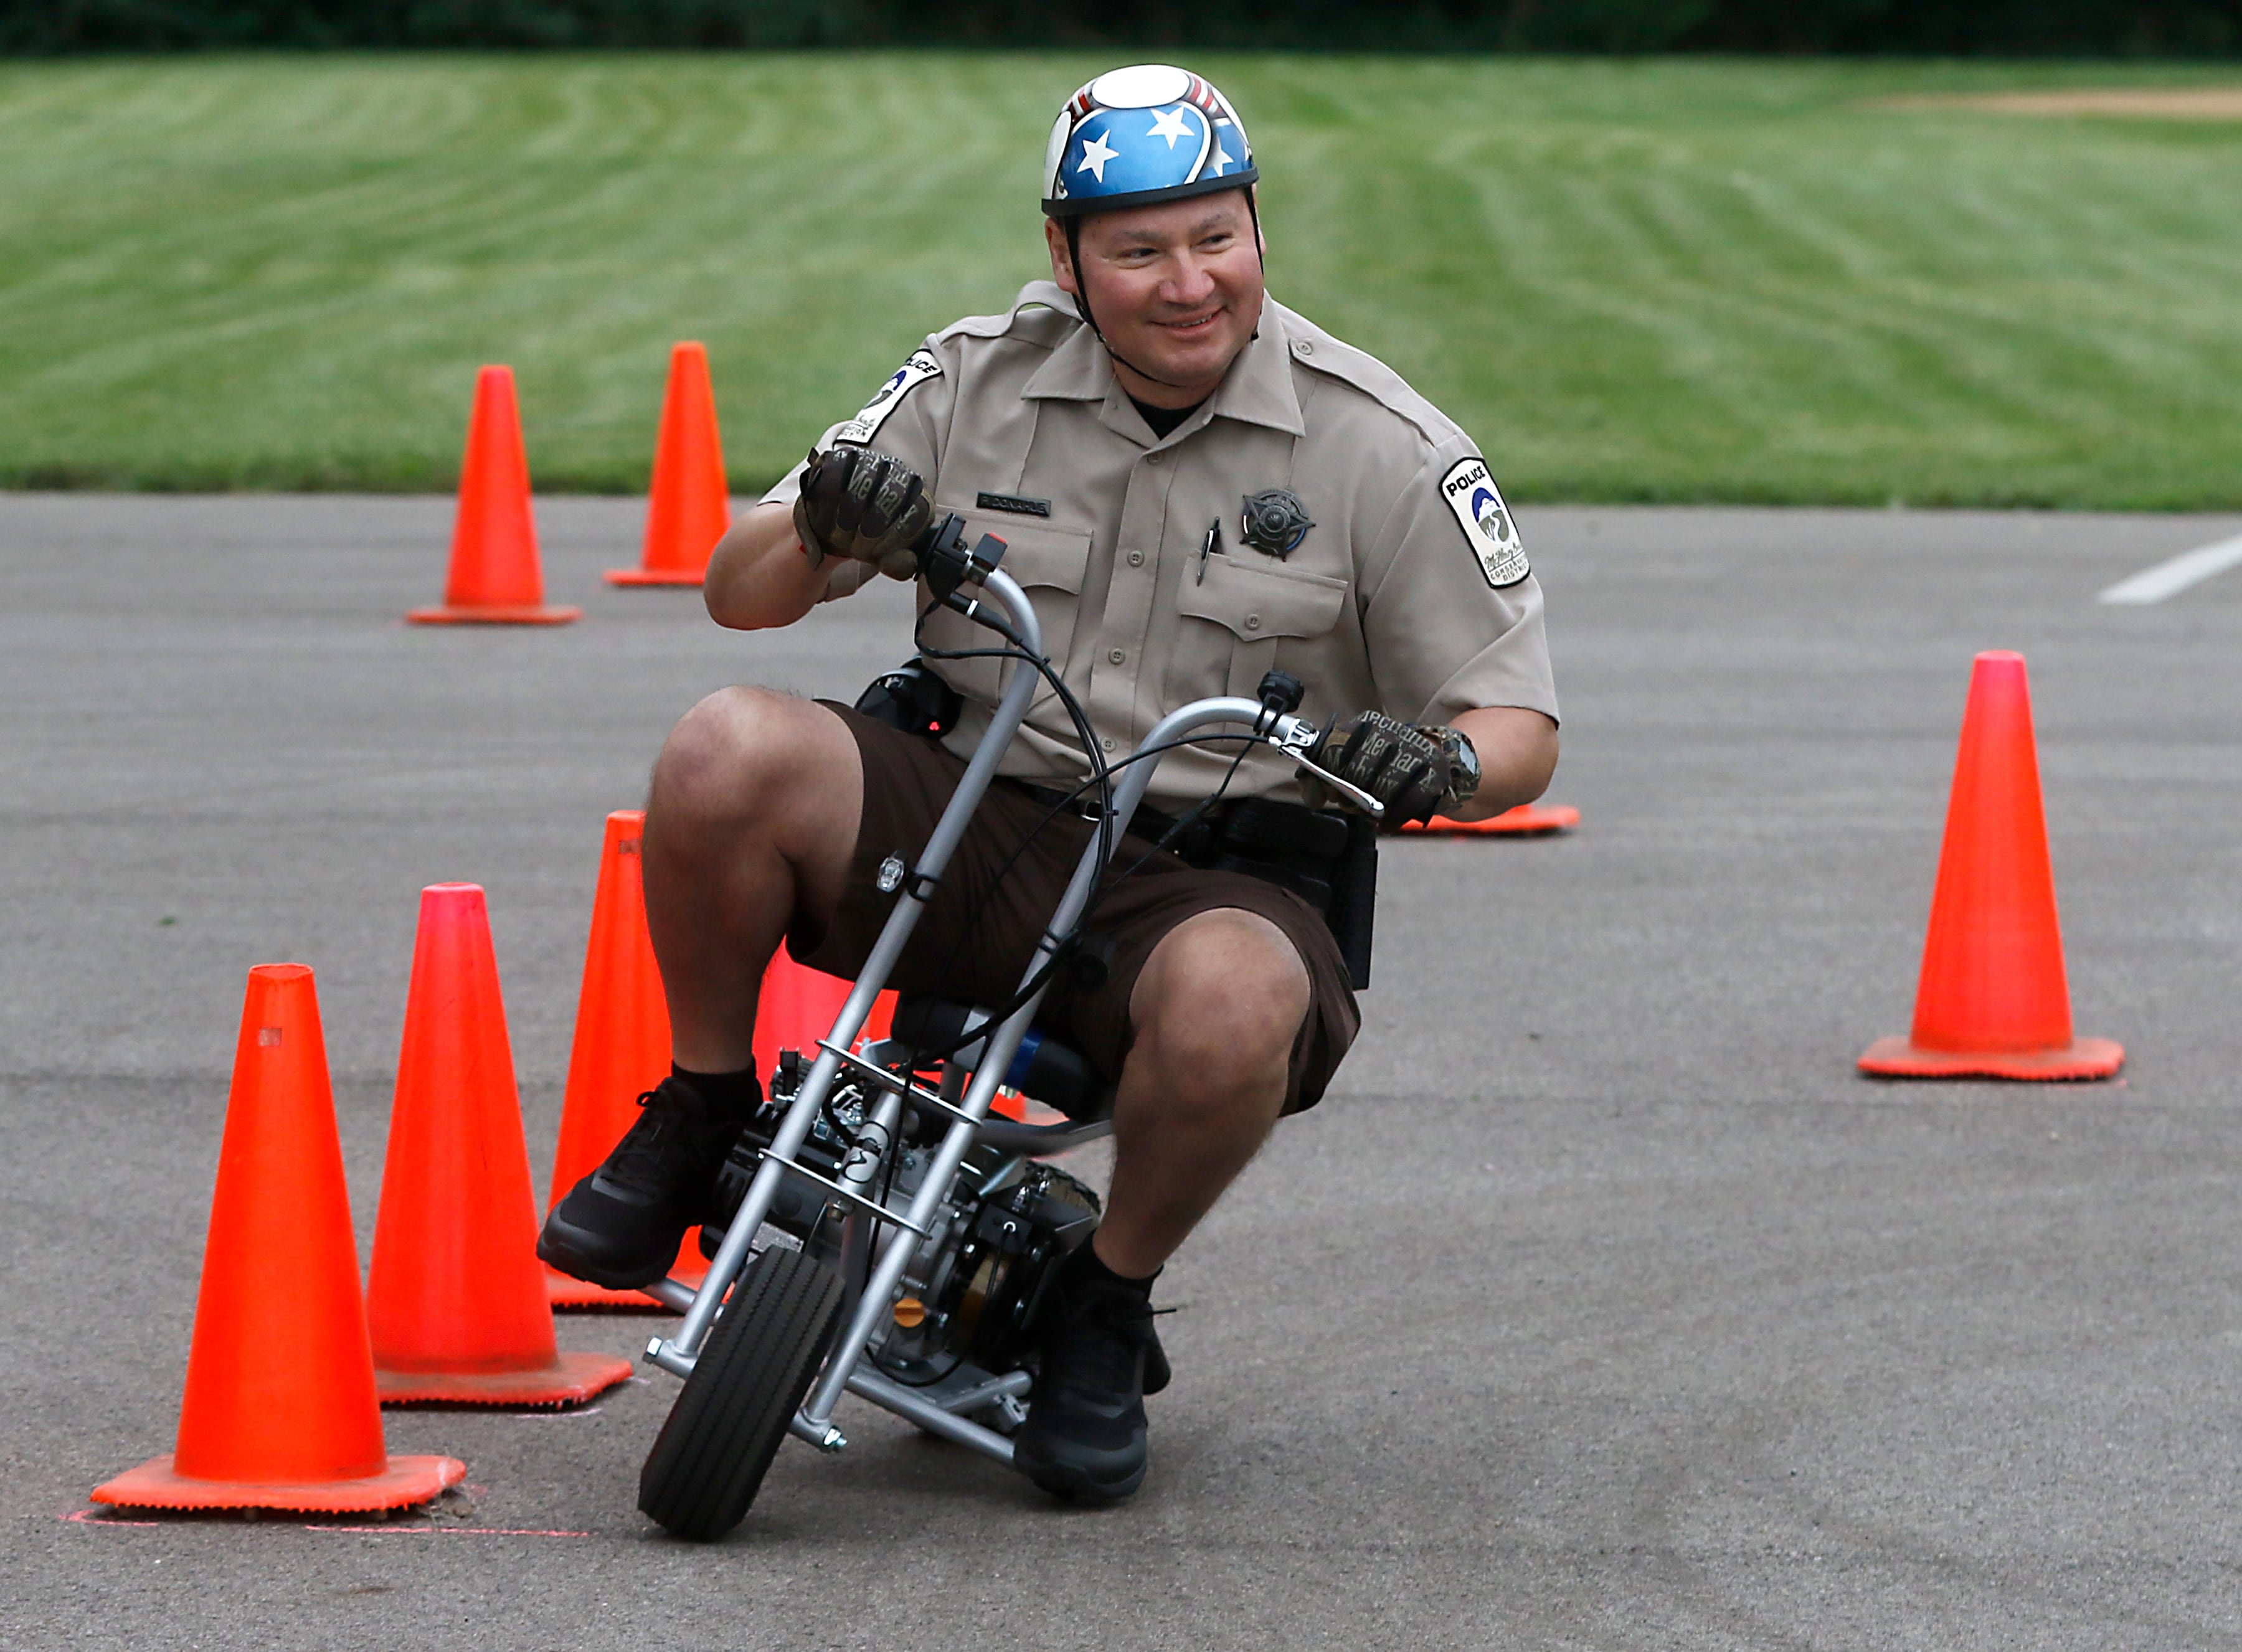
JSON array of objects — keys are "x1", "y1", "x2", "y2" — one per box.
[{"x1": 639, "y1": 516, "x2": 1383, "y2": 1537}]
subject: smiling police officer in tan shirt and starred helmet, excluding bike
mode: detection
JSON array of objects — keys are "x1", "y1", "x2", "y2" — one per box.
[{"x1": 541, "y1": 65, "x2": 1556, "y2": 1498}]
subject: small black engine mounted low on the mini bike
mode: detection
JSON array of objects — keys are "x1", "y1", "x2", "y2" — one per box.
[{"x1": 699, "y1": 1049, "x2": 1099, "y2": 1385}]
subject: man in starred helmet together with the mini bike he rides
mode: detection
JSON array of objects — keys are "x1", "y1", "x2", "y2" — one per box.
[{"x1": 538, "y1": 65, "x2": 1556, "y2": 1537}]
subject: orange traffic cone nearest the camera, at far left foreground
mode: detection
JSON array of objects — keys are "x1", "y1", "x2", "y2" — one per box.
[{"x1": 94, "y1": 964, "x2": 466, "y2": 1513}]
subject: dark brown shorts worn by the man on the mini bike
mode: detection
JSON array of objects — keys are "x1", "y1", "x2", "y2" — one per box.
[{"x1": 787, "y1": 699, "x2": 1361, "y2": 1112}]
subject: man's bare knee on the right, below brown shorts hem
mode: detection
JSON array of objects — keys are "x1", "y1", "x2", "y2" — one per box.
[{"x1": 1130, "y1": 908, "x2": 1312, "y2": 1096}]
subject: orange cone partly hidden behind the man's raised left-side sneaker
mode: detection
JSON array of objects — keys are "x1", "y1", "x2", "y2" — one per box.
[{"x1": 545, "y1": 809, "x2": 709, "y2": 1311}]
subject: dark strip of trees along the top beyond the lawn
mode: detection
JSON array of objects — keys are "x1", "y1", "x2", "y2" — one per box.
[{"x1": 0, "y1": 0, "x2": 2242, "y2": 56}]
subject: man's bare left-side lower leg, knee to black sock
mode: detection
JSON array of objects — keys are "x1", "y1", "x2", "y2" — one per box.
[{"x1": 643, "y1": 688, "x2": 863, "y2": 1074}]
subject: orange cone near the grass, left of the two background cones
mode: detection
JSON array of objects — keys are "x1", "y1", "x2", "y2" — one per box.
[{"x1": 406, "y1": 367, "x2": 583, "y2": 625}]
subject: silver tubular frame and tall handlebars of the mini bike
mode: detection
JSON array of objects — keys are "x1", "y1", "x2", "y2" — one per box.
[{"x1": 646, "y1": 569, "x2": 1376, "y2": 1464}]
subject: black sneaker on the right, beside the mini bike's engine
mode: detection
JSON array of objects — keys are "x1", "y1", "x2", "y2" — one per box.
[{"x1": 1011, "y1": 1244, "x2": 1168, "y2": 1502}]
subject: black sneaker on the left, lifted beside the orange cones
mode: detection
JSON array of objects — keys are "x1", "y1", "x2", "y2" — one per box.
[{"x1": 538, "y1": 1076, "x2": 742, "y2": 1291}]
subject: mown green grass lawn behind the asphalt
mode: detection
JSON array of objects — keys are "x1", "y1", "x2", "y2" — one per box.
[{"x1": 0, "y1": 54, "x2": 2242, "y2": 509}]
